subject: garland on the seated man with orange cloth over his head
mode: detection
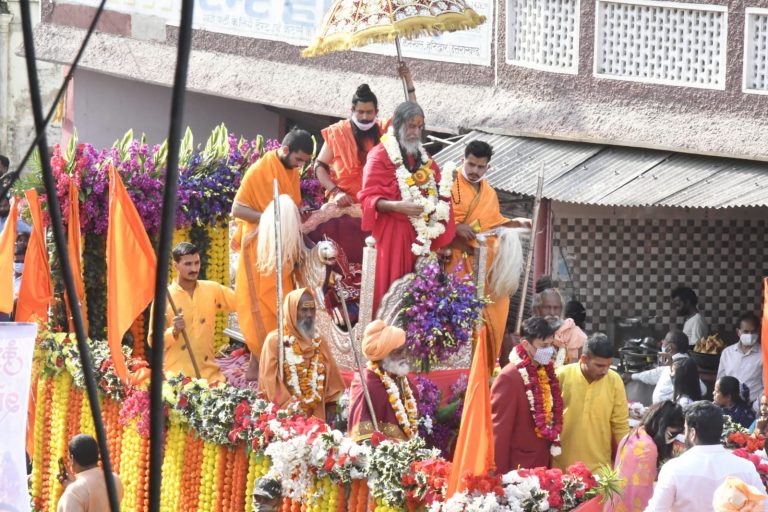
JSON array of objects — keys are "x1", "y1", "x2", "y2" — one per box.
[{"x1": 284, "y1": 336, "x2": 325, "y2": 414}]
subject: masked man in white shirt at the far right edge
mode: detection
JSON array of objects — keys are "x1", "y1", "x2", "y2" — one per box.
[{"x1": 717, "y1": 313, "x2": 764, "y2": 408}]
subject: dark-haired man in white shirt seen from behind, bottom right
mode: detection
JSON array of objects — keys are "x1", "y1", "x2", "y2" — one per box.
[{"x1": 645, "y1": 401, "x2": 768, "y2": 512}]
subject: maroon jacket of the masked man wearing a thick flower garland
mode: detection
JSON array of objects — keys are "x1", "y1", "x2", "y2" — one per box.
[{"x1": 491, "y1": 364, "x2": 551, "y2": 475}]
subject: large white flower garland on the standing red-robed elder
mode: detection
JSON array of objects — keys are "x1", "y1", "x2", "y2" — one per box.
[{"x1": 381, "y1": 127, "x2": 453, "y2": 256}]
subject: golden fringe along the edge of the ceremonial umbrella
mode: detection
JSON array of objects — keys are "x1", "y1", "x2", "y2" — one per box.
[{"x1": 301, "y1": 9, "x2": 485, "y2": 57}]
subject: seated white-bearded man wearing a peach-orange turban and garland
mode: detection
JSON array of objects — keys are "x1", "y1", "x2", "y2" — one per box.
[{"x1": 348, "y1": 320, "x2": 419, "y2": 442}]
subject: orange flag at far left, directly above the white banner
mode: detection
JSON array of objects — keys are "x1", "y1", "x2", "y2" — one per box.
[{"x1": 16, "y1": 189, "x2": 53, "y2": 322}]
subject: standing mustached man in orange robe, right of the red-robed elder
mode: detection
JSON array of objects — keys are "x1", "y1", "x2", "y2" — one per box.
[{"x1": 449, "y1": 140, "x2": 531, "y2": 371}]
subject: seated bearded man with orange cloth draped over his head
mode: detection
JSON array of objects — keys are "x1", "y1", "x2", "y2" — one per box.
[{"x1": 259, "y1": 288, "x2": 345, "y2": 420}]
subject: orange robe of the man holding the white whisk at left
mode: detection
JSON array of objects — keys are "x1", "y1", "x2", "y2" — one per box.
[{"x1": 232, "y1": 150, "x2": 301, "y2": 357}]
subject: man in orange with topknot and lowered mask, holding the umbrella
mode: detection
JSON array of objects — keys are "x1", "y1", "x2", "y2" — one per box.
[{"x1": 315, "y1": 62, "x2": 416, "y2": 207}]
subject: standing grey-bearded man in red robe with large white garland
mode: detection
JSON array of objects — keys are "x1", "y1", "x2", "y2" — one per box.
[{"x1": 357, "y1": 102, "x2": 456, "y2": 311}]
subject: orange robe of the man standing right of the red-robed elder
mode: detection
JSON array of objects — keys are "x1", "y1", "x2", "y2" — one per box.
[{"x1": 448, "y1": 170, "x2": 510, "y2": 372}]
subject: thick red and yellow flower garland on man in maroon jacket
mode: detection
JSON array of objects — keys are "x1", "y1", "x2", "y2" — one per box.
[{"x1": 510, "y1": 344, "x2": 563, "y2": 457}]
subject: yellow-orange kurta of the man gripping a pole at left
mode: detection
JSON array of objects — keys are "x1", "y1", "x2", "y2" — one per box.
[{"x1": 149, "y1": 280, "x2": 235, "y2": 382}]
